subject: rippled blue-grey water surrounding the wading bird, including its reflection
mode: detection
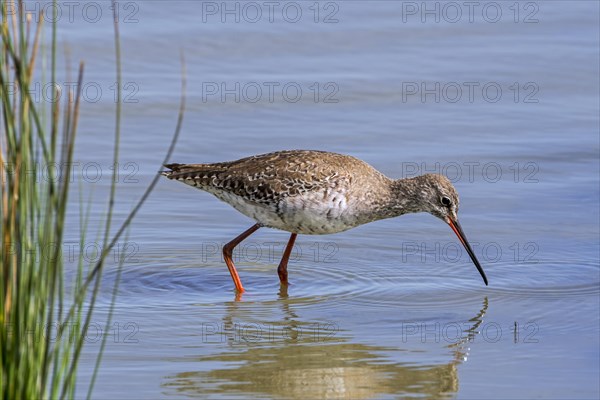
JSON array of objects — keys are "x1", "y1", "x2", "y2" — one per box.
[{"x1": 37, "y1": 1, "x2": 600, "y2": 399}]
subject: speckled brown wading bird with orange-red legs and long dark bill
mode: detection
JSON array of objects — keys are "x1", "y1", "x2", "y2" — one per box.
[{"x1": 162, "y1": 150, "x2": 488, "y2": 293}]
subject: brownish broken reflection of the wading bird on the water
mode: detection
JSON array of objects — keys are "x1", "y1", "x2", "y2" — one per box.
[{"x1": 164, "y1": 296, "x2": 488, "y2": 399}]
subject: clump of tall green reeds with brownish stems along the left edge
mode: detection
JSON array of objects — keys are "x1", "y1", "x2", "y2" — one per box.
[{"x1": 0, "y1": 0, "x2": 185, "y2": 399}]
